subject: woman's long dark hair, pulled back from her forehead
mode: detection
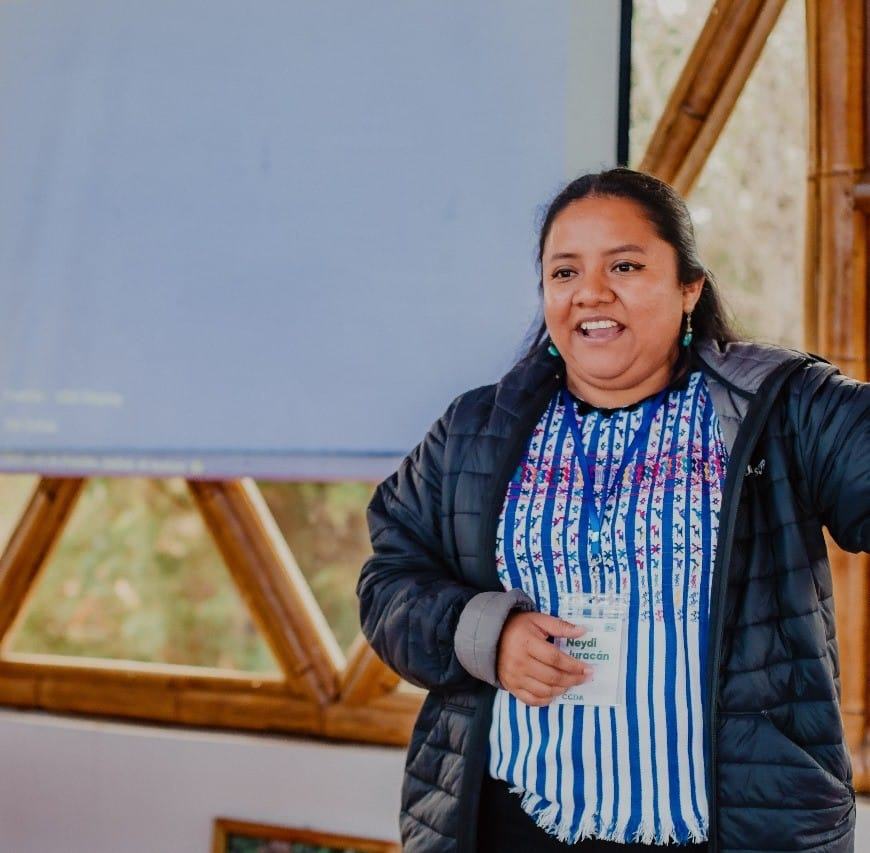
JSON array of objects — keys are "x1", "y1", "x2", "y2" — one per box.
[{"x1": 525, "y1": 168, "x2": 738, "y2": 361}]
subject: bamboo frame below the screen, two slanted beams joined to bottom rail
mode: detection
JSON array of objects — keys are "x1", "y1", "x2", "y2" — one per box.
[{"x1": 0, "y1": 477, "x2": 420, "y2": 744}]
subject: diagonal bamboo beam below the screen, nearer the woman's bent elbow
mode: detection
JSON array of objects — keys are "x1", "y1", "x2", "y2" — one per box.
[{"x1": 188, "y1": 480, "x2": 344, "y2": 704}]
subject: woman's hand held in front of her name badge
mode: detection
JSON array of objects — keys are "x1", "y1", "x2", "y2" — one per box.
[{"x1": 496, "y1": 611, "x2": 592, "y2": 705}]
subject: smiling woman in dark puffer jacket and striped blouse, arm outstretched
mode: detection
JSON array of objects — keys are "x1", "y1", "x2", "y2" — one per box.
[{"x1": 358, "y1": 169, "x2": 870, "y2": 853}]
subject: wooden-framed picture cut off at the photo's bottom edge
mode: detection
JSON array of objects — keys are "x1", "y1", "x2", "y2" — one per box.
[{"x1": 212, "y1": 818, "x2": 401, "y2": 853}]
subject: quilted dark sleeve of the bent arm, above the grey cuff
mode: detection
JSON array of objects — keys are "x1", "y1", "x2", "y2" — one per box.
[{"x1": 357, "y1": 398, "x2": 479, "y2": 690}]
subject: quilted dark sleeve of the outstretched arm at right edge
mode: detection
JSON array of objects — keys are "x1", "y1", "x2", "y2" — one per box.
[{"x1": 792, "y1": 364, "x2": 870, "y2": 553}]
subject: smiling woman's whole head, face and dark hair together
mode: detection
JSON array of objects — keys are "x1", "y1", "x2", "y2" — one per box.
[{"x1": 536, "y1": 169, "x2": 736, "y2": 408}]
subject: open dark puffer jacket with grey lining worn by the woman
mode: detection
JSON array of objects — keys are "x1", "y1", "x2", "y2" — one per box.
[{"x1": 358, "y1": 342, "x2": 870, "y2": 853}]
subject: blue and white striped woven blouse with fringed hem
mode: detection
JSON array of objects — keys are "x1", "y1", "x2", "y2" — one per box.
[{"x1": 489, "y1": 372, "x2": 727, "y2": 844}]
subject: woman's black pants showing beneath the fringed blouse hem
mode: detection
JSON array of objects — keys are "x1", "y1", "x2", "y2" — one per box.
[{"x1": 477, "y1": 774, "x2": 707, "y2": 853}]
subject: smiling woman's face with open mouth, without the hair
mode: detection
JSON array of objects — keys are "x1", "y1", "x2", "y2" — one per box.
[{"x1": 542, "y1": 196, "x2": 704, "y2": 405}]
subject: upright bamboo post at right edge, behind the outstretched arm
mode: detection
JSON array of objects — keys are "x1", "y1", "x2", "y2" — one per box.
[{"x1": 804, "y1": 0, "x2": 870, "y2": 791}]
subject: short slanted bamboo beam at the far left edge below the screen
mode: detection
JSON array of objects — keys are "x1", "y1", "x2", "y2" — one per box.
[{"x1": 0, "y1": 477, "x2": 84, "y2": 647}]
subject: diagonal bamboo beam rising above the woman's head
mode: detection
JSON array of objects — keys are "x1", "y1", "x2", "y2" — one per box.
[{"x1": 639, "y1": 0, "x2": 785, "y2": 195}]
